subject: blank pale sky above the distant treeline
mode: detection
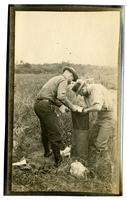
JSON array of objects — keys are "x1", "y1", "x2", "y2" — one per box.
[{"x1": 15, "y1": 11, "x2": 120, "y2": 67}]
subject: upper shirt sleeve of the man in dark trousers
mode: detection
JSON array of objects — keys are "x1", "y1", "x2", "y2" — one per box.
[{"x1": 57, "y1": 80, "x2": 68, "y2": 101}]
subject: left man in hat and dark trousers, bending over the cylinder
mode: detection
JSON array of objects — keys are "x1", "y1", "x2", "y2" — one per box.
[{"x1": 34, "y1": 67, "x2": 78, "y2": 167}]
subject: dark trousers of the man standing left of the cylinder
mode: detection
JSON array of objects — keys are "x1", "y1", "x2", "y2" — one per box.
[{"x1": 34, "y1": 100, "x2": 61, "y2": 163}]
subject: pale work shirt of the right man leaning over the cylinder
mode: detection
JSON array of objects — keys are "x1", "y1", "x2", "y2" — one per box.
[{"x1": 84, "y1": 84, "x2": 112, "y2": 111}]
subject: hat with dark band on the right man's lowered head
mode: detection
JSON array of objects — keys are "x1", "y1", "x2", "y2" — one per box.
[{"x1": 72, "y1": 79, "x2": 87, "y2": 95}]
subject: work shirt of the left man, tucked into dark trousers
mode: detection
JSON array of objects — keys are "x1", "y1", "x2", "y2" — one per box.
[{"x1": 37, "y1": 75, "x2": 73, "y2": 108}]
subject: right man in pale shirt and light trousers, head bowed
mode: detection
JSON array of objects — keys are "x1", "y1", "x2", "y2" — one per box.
[{"x1": 72, "y1": 80, "x2": 113, "y2": 158}]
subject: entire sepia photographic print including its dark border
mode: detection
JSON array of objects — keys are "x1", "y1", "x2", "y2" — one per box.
[{"x1": 4, "y1": 5, "x2": 124, "y2": 196}]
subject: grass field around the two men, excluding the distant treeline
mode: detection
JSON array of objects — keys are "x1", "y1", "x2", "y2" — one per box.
[{"x1": 12, "y1": 64, "x2": 119, "y2": 194}]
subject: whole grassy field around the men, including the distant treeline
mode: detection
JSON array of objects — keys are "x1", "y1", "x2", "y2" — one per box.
[{"x1": 12, "y1": 62, "x2": 119, "y2": 194}]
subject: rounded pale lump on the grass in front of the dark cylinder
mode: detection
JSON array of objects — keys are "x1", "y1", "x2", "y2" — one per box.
[{"x1": 70, "y1": 160, "x2": 89, "y2": 180}]
